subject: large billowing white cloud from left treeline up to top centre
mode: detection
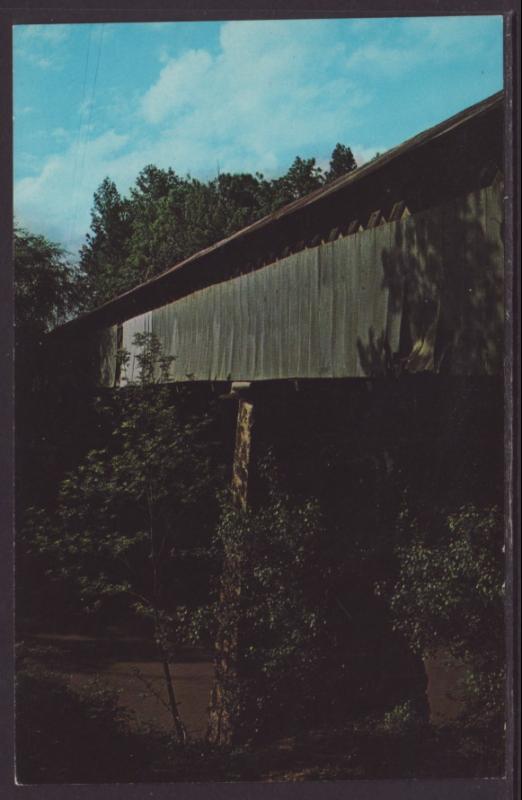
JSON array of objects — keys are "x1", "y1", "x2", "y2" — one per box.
[{"x1": 19, "y1": 21, "x2": 363, "y2": 249}]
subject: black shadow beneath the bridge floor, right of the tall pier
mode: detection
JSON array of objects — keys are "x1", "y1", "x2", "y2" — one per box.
[{"x1": 244, "y1": 372, "x2": 503, "y2": 760}]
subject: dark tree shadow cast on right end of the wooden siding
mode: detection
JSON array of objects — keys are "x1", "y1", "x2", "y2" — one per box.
[{"x1": 357, "y1": 182, "x2": 504, "y2": 377}]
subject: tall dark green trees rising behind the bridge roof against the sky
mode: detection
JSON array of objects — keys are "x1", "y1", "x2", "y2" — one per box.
[{"x1": 80, "y1": 144, "x2": 355, "y2": 308}]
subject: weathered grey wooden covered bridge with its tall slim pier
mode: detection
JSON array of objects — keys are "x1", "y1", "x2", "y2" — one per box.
[{"x1": 49, "y1": 93, "x2": 504, "y2": 741}]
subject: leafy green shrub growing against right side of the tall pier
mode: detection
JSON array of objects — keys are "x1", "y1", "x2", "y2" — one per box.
[{"x1": 210, "y1": 458, "x2": 325, "y2": 739}]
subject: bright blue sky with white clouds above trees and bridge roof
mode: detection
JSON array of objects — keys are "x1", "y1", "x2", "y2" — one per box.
[{"x1": 13, "y1": 16, "x2": 503, "y2": 254}]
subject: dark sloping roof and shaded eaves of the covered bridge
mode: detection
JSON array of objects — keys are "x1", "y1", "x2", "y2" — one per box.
[{"x1": 53, "y1": 92, "x2": 503, "y2": 336}]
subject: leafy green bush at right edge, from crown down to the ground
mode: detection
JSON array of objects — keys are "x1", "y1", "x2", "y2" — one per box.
[{"x1": 391, "y1": 505, "x2": 505, "y2": 763}]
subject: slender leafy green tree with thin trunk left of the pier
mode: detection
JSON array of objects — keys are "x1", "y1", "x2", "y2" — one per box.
[{"x1": 23, "y1": 334, "x2": 222, "y2": 743}]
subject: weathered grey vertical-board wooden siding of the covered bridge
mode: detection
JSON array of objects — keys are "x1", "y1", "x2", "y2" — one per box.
[{"x1": 97, "y1": 184, "x2": 503, "y2": 385}]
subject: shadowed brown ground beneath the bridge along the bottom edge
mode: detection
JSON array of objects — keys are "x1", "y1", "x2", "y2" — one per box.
[{"x1": 17, "y1": 634, "x2": 498, "y2": 783}]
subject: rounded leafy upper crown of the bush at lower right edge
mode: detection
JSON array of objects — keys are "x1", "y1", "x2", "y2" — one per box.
[{"x1": 392, "y1": 506, "x2": 504, "y2": 659}]
